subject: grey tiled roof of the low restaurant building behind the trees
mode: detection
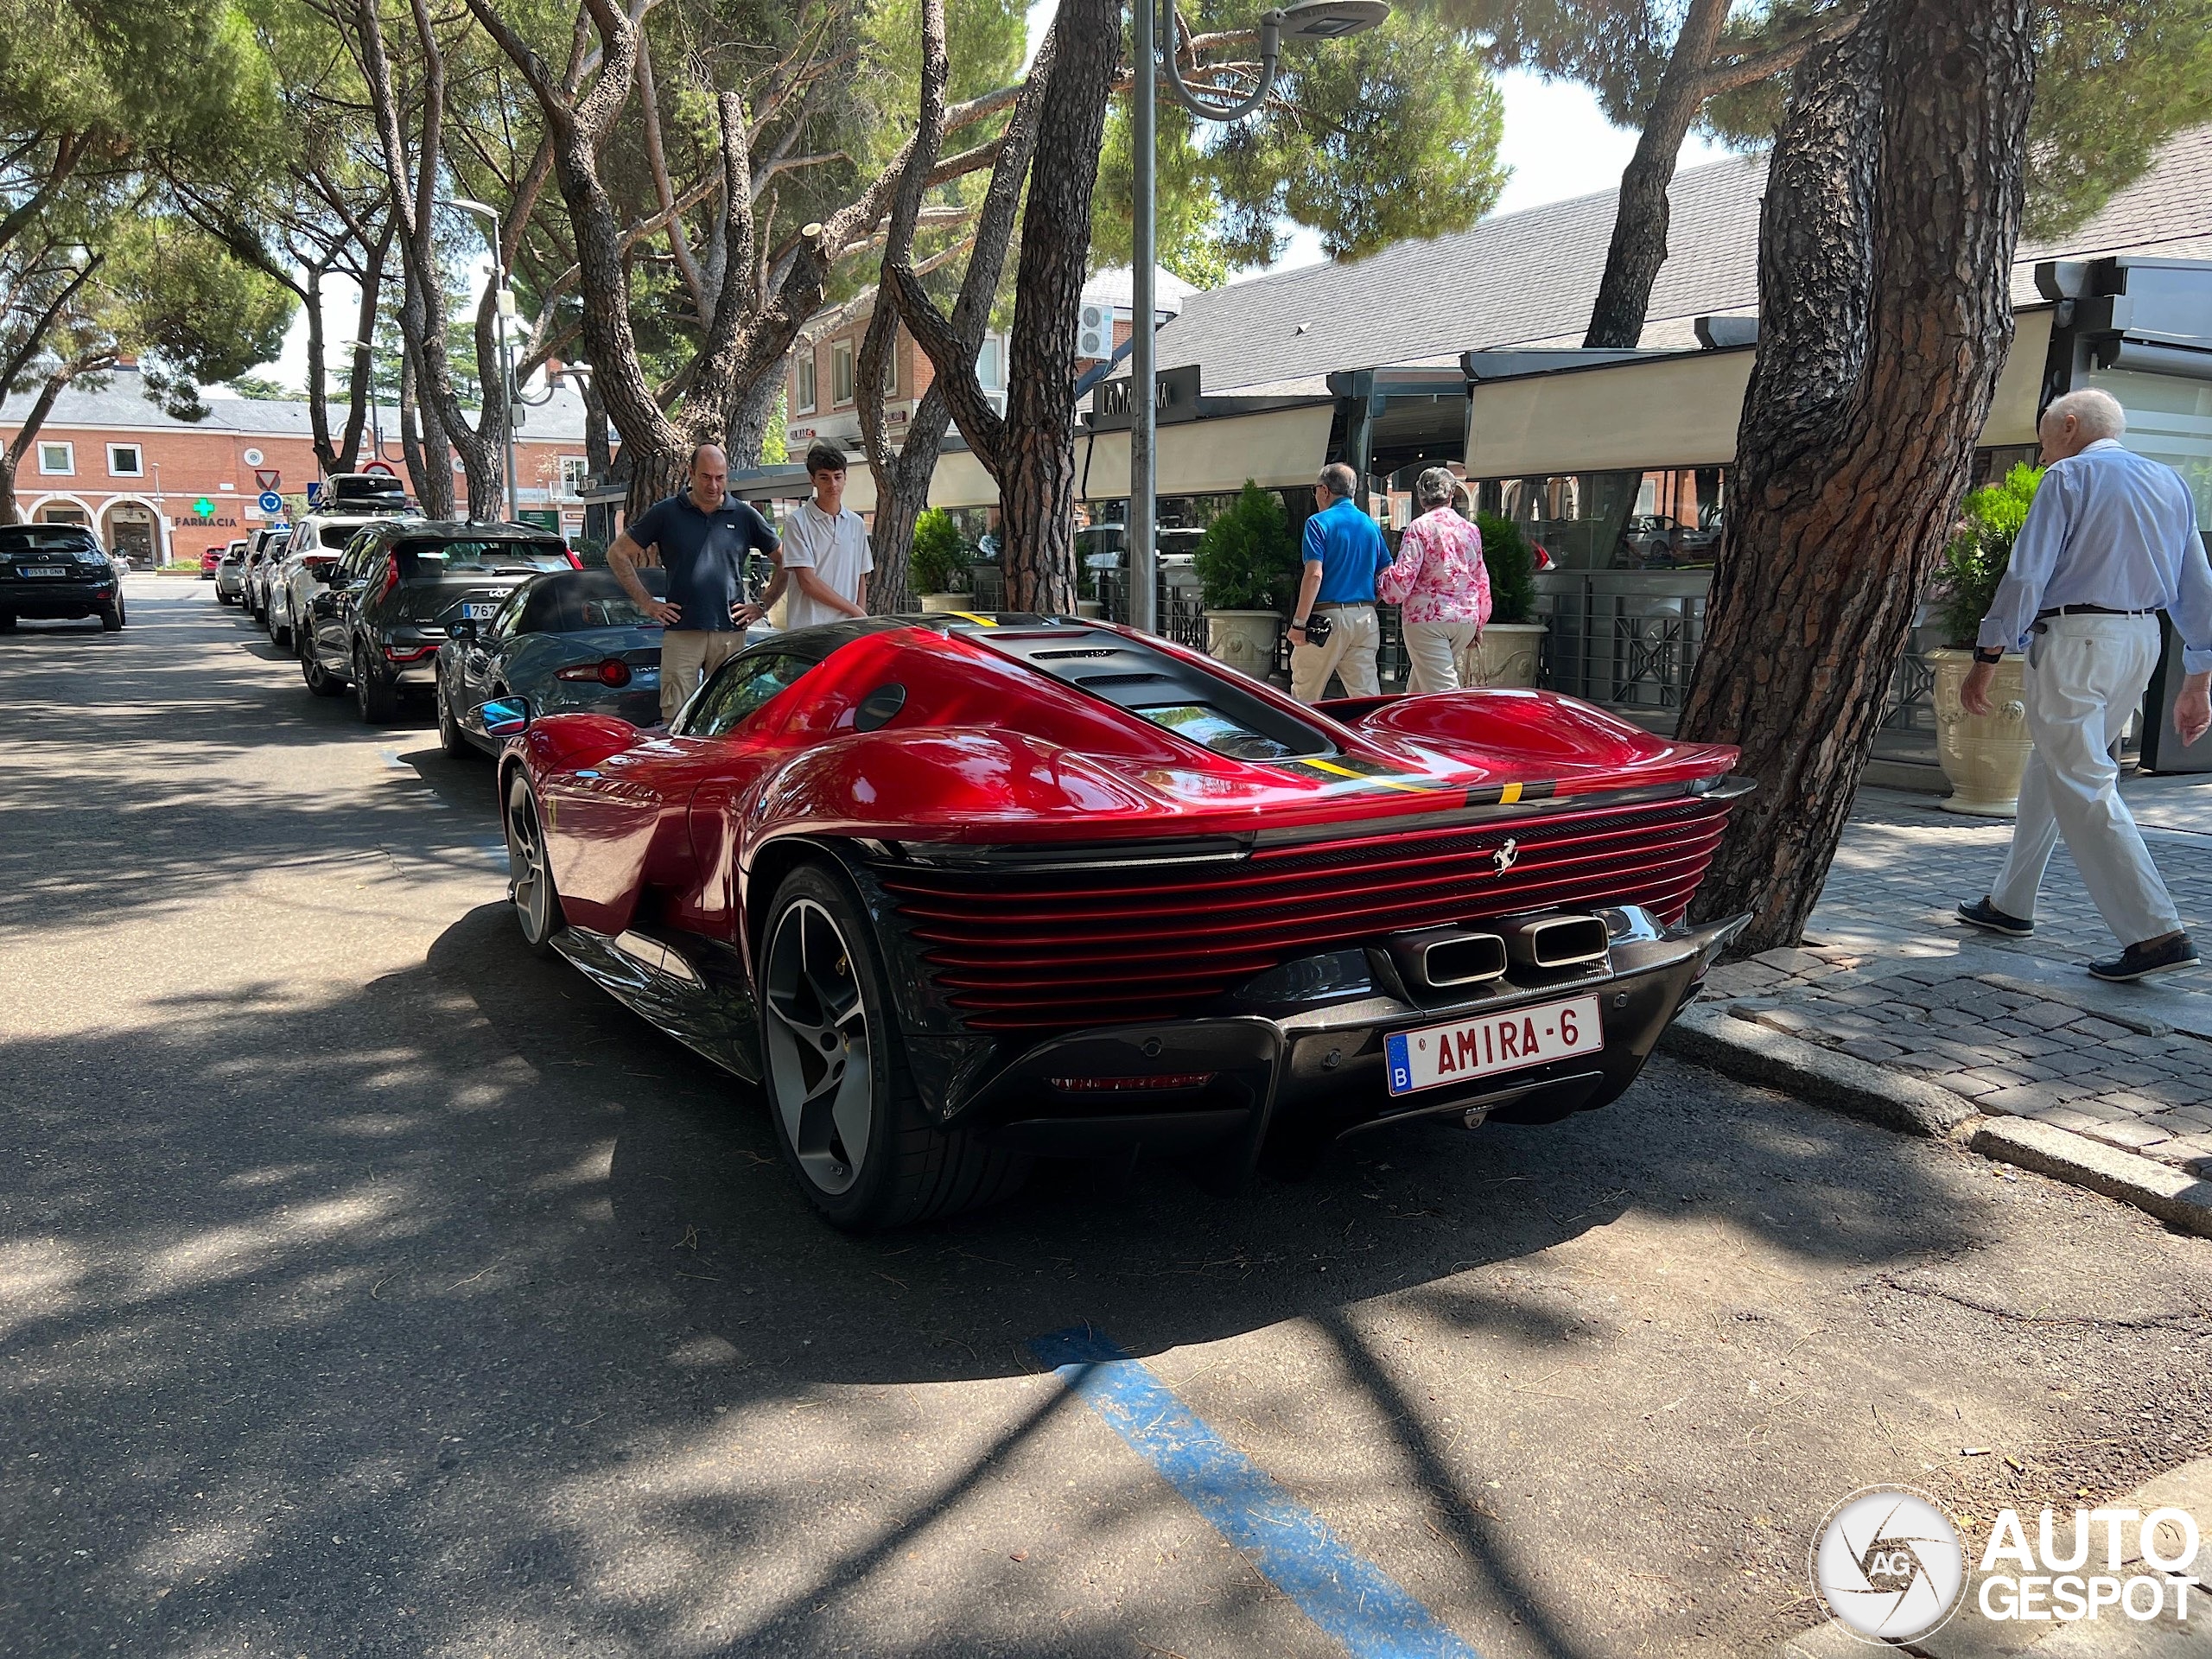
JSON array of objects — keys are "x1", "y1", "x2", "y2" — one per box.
[{"x1": 1159, "y1": 126, "x2": 2212, "y2": 391}]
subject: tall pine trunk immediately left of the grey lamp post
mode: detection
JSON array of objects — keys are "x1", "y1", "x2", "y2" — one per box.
[{"x1": 995, "y1": 0, "x2": 1122, "y2": 613}]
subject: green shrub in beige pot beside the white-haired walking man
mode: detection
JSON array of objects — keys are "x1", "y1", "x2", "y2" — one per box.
[{"x1": 1929, "y1": 465, "x2": 2044, "y2": 818}]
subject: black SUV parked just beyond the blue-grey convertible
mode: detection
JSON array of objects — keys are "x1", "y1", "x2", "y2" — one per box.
[{"x1": 296, "y1": 518, "x2": 579, "y2": 723}]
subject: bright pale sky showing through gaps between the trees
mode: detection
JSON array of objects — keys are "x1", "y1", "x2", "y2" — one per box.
[{"x1": 264, "y1": 49, "x2": 1727, "y2": 387}]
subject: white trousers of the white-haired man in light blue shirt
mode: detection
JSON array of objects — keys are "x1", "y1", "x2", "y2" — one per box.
[{"x1": 1988, "y1": 617, "x2": 2181, "y2": 944}]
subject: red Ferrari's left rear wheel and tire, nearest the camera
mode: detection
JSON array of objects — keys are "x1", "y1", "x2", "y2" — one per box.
[{"x1": 759, "y1": 862, "x2": 1028, "y2": 1232}]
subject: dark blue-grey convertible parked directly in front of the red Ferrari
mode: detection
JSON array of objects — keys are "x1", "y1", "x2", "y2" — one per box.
[{"x1": 438, "y1": 566, "x2": 668, "y2": 754}]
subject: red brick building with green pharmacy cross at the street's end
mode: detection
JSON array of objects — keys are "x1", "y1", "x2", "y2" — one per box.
[{"x1": 0, "y1": 370, "x2": 606, "y2": 562}]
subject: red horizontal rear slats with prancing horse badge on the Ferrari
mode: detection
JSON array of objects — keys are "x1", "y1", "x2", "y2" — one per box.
[{"x1": 880, "y1": 801, "x2": 1727, "y2": 1031}]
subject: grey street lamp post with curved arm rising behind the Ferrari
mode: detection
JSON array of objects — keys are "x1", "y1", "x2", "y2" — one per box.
[{"x1": 1128, "y1": 0, "x2": 1389, "y2": 632}]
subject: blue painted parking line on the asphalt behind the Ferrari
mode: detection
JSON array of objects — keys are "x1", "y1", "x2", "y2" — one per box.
[{"x1": 1028, "y1": 1325, "x2": 1480, "y2": 1659}]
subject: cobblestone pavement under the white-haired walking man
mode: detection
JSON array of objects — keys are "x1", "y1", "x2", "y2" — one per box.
[{"x1": 1710, "y1": 779, "x2": 2212, "y2": 1177}]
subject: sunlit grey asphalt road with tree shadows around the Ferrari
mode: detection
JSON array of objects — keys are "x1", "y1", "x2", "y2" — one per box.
[{"x1": 0, "y1": 577, "x2": 2212, "y2": 1659}]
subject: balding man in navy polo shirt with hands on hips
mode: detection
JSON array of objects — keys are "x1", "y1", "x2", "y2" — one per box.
[{"x1": 606, "y1": 445, "x2": 777, "y2": 723}]
